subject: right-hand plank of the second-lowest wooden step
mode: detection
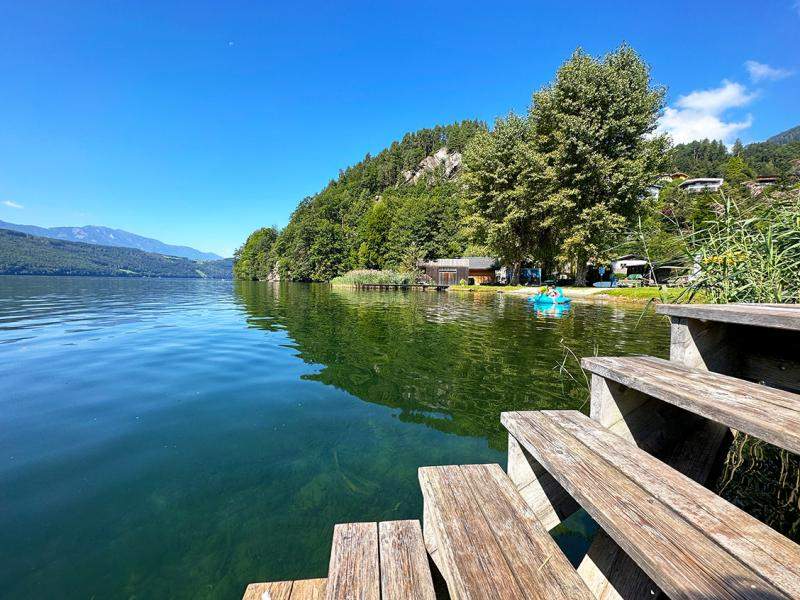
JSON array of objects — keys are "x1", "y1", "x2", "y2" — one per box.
[{"x1": 378, "y1": 521, "x2": 436, "y2": 600}]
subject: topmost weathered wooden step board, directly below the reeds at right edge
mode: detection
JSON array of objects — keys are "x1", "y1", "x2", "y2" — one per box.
[{"x1": 656, "y1": 304, "x2": 800, "y2": 331}]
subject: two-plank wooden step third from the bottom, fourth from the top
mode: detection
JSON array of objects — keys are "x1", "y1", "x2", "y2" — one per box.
[{"x1": 419, "y1": 465, "x2": 592, "y2": 600}]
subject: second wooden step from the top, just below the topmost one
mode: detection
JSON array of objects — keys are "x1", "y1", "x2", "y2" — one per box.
[{"x1": 581, "y1": 354, "x2": 800, "y2": 454}]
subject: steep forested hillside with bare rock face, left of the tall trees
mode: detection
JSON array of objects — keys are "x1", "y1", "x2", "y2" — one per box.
[{"x1": 262, "y1": 121, "x2": 486, "y2": 281}]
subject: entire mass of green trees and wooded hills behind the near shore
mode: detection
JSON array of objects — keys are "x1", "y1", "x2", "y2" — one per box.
[{"x1": 234, "y1": 46, "x2": 800, "y2": 283}]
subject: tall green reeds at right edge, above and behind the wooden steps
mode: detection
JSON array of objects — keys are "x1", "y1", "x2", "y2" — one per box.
[{"x1": 687, "y1": 193, "x2": 800, "y2": 541}]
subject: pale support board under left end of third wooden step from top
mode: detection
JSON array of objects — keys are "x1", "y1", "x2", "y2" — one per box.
[{"x1": 508, "y1": 435, "x2": 580, "y2": 531}]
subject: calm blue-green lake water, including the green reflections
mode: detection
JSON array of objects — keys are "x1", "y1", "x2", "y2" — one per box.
[{"x1": 0, "y1": 277, "x2": 668, "y2": 599}]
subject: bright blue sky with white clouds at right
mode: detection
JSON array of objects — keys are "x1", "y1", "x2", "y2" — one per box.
[{"x1": 0, "y1": 0, "x2": 800, "y2": 255}]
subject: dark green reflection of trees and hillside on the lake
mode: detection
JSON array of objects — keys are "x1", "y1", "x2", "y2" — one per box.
[{"x1": 235, "y1": 282, "x2": 666, "y2": 450}]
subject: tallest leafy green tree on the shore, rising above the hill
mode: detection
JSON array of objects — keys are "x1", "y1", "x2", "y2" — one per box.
[{"x1": 526, "y1": 46, "x2": 668, "y2": 285}]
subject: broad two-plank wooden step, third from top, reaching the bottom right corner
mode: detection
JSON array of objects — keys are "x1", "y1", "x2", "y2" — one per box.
[{"x1": 502, "y1": 411, "x2": 800, "y2": 600}]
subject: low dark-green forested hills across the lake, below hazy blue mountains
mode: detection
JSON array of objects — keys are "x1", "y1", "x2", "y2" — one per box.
[{"x1": 0, "y1": 229, "x2": 232, "y2": 279}]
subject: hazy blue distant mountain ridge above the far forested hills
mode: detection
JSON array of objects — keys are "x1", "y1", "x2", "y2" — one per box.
[{"x1": 0, "y1": 221, "x2": 222, "y2": 260}]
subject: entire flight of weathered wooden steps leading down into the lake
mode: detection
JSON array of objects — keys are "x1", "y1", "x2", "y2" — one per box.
[{"x1": 244, "y1": 304, "x2": 800, "y2": 600}]
